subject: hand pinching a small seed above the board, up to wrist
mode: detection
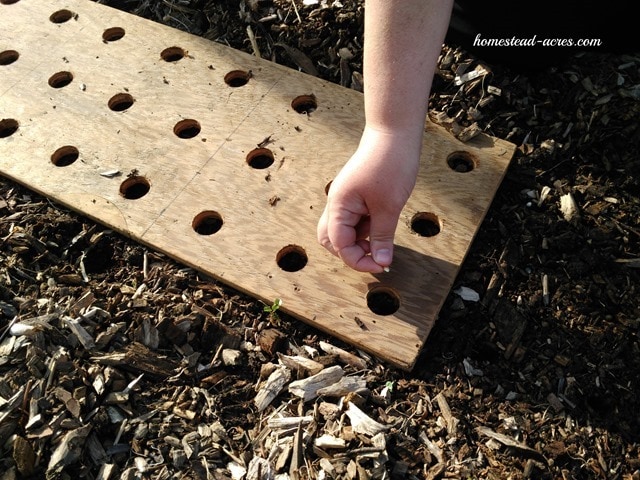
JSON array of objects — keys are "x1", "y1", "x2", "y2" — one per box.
[{"x1": 318, "y1": 127, "x2": 422, "y2": 273}]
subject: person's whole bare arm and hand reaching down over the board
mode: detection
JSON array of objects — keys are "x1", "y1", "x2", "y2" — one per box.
[{"x1": 318, "y1": 0, "x2": 453, "y2": 273}]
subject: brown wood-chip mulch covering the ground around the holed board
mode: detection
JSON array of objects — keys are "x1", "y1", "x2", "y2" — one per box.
[{"x1": 0, "y1": 0, "x2": 640, "y2": 480}]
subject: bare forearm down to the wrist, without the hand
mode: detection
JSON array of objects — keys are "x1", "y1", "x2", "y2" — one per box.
[{"x1": 364, "y1": 0, "x2": 453, "y2": 141}]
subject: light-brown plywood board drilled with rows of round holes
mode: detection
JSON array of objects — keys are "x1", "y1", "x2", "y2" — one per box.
[{"x1": 0, "y1": 0, "x2": 514, "y2": 369}]
